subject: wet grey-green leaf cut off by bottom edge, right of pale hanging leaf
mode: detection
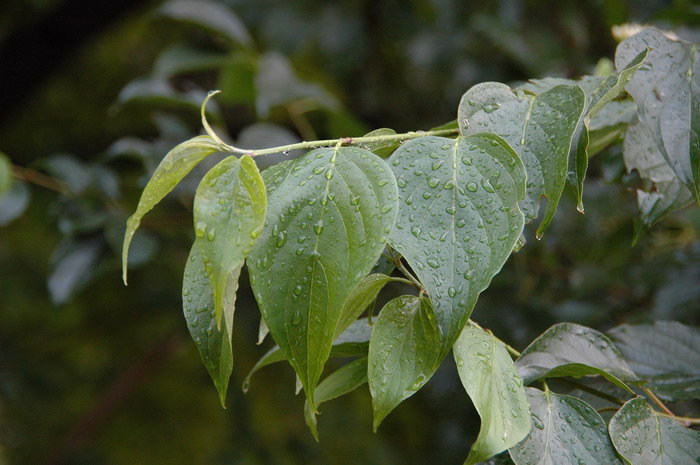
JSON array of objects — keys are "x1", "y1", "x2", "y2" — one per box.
[{"x1": 510, "y1": 388, "x2": 621, "y2": 465}]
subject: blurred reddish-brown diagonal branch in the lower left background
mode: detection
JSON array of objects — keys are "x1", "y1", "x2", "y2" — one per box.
[{"x1": 45, "y1": 333, "x2": 185, "y2": 465}]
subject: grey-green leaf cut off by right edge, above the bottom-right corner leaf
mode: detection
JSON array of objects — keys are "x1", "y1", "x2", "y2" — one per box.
[{"x1": 608, "y1": 321, "x2": 700, "y2": 402}]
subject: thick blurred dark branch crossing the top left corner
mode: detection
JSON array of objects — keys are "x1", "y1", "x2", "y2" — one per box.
[{"x1": 0, "y1": 0, "x2": 157, "y2": 127}]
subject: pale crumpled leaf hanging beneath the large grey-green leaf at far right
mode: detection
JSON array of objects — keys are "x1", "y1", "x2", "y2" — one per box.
[{"x1": 623, "y1": 123, "x2": 693, "y2": 237}]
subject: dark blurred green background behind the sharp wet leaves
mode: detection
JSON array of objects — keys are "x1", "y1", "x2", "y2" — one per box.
[{"x1": 0, "y1": 0, "x2": 700, "y2": 465}]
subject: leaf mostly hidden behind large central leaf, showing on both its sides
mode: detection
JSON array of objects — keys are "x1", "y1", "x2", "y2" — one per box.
[{"x1": 243, "y1": 318, "x2": 372, "y2": 392}]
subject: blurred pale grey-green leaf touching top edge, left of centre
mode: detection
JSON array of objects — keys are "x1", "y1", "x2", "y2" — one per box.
[{"x1": 159, "y1": 0, "x2": 251, "y2": 46}]
